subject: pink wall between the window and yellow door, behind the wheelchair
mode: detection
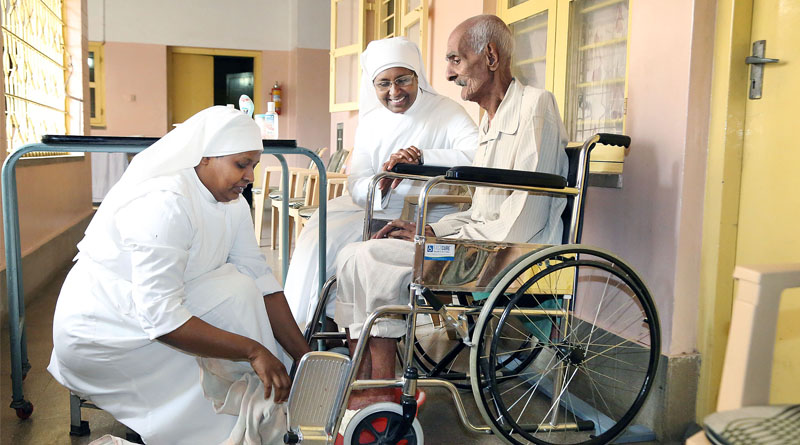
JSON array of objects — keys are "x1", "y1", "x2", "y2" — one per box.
[{"x1": 583, "y1": 0, "x2": 713, "y2": 354}]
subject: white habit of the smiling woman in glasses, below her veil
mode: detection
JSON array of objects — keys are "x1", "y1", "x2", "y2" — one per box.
[{"x1": 284, "y1": 91, "x2": 478, "y2": 327}]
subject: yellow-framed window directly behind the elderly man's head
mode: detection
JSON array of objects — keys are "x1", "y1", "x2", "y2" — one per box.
[{"x1": 497, "y1": 0, "x2": 628, "y2": 144}]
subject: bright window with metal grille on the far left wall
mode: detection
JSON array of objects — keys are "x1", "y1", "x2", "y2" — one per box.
[{"x1": 0, "y1": 0, "x2": 67, "y2": 152}]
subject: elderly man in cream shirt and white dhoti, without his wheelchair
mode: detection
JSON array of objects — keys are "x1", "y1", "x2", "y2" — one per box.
[{"x1": 334, "y1": 15, "x2": 568, "y2": 409}]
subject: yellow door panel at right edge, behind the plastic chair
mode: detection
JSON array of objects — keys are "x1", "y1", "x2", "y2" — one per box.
[{"x1": 736, "y1": 0, "x2": 800, "y2": 403}]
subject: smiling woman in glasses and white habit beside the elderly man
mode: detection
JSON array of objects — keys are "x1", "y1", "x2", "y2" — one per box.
[{"x1": 284, "y1": 37, "x2": 478, "y2": 327}]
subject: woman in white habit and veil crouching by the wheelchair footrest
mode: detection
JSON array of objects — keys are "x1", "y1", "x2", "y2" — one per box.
[{"x1": 48, "y1": 107, "x2": 308, "y2": 445}]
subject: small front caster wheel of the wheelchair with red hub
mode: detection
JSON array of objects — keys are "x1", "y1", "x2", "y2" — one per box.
[{"x1": 343, "y1": 402, "x2": 424, "y2": 445}]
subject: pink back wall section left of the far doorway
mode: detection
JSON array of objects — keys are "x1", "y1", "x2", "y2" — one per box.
[{"x1": 92, "y1": 42, "x2": 168, "y2": 137}]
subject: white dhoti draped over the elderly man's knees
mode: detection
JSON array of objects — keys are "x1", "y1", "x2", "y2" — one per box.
[{"x1": 334, "y1": 239, "x2": 415, "y2": 338}]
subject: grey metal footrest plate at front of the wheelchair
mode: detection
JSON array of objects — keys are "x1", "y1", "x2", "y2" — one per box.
[{"x1": 288, "y1": 351, "x2": 350, "y2": 433}]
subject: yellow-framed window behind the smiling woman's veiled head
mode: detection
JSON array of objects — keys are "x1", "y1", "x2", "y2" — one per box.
[{"x1": 330, "y1": 0, "x2": 428, "y2": 112}]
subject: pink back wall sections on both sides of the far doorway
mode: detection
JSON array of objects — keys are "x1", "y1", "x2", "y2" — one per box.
[{"x1": 92, "y1": 42, "x2": 330, "y2": 175}]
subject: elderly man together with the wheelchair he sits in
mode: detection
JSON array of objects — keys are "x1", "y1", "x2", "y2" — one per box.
[{"x1": 285, "y1": 16, "x2": 660, "y2": 444}]
